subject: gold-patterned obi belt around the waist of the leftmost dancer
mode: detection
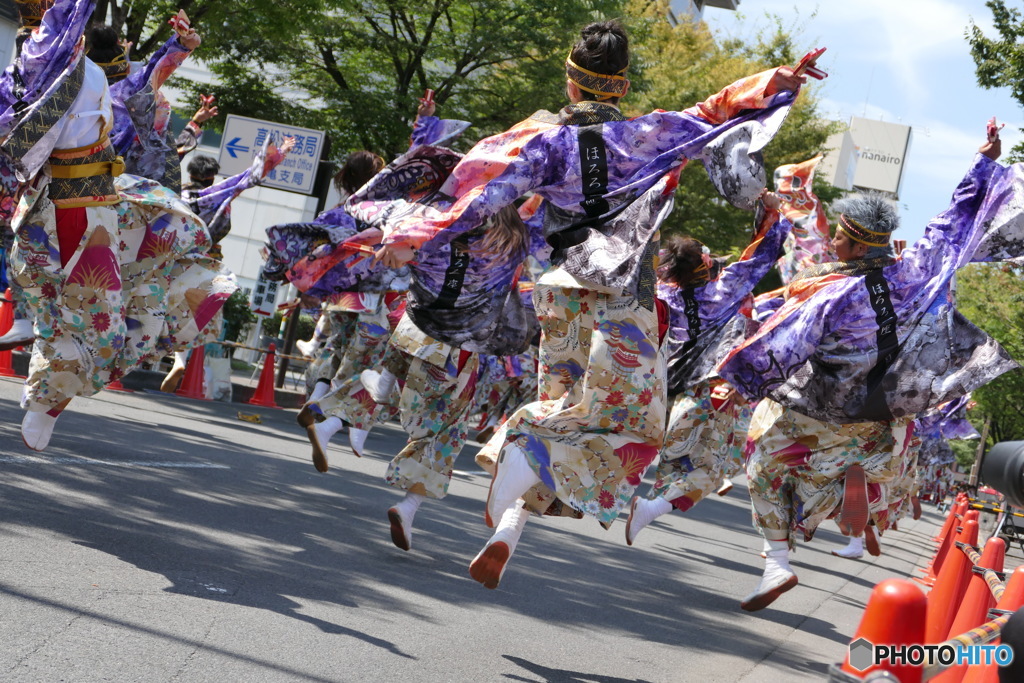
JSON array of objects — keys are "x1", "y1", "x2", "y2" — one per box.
[{"x1": 49, "y1": 136, "x2": 125, "y2": 209}]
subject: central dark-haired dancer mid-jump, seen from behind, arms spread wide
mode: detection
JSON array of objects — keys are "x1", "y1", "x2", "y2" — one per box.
[{"x1": 362, "y1": 23, "x2": 815, "y2": 588}]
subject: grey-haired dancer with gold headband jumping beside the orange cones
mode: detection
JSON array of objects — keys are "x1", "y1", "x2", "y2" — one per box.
[{"x1": 720, "y1": 126, "x2": 1024, "y2": 610}]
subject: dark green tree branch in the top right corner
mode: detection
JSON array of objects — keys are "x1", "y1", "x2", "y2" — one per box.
[{"x1": 967, "y1": 0, "x2": 1024, "y2": 161}]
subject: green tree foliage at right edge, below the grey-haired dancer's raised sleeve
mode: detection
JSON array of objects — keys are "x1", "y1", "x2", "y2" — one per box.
[{"x1": 956, "y1": 263, "x2": 1024, "y2": 443}]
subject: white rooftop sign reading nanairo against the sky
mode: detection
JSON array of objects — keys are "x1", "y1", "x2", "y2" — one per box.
[{"x1": 850, "y1": 117, "x2": 910, "y2": 199}]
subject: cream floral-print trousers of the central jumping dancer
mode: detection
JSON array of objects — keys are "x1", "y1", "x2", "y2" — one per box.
[{"x1": 477, "y1": 276, "x2": 667, "y2": 525}]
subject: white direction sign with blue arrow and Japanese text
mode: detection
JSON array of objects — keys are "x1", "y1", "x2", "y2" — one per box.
[{"x1": 217, "y1": 114, "x2": 324, "y2": 195}]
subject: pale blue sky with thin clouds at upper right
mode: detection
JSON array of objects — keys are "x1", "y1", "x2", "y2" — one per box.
[{"x1": 705, "y1": 0, "x2": 1024, "y2": 242}]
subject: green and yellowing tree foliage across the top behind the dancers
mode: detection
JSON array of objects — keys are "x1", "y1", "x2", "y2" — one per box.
[{"x1": 97, "y1": 0, "x2": 838, "y2": 253}]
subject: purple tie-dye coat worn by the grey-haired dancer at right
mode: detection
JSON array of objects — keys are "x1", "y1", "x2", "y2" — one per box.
[{"x1": 720, "y1": 155, "x2": 1024, "y2": 424}]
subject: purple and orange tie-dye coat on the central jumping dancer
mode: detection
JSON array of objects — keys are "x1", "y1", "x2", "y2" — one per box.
[{"x1": 348, "y1": 82, "x2": 795, "y2": 292}]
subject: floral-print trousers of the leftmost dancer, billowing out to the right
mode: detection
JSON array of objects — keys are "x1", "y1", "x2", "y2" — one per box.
[{"x1": 11, "y1": 175, "x2": 237, "y2": 407}]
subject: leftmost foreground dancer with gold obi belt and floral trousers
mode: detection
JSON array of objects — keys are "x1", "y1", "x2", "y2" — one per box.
[{"x1": 0, "y1": 0, "x2": 236, "y2": 451}]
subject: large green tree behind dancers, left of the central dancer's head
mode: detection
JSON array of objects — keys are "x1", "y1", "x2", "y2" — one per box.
[{"x1": 167, "y1": 0, "x2": 625, "y2": 158}]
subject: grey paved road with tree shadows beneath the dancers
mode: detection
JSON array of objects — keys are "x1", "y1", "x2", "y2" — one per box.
[{"x1": 0, "y1": 380, "x2": 974, "y2": 683}]
